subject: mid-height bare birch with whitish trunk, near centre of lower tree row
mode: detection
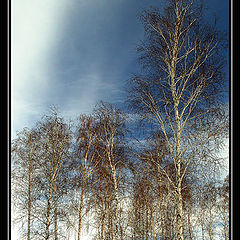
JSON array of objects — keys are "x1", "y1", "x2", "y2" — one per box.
[{"x1": 94, "y1": 102, "x2": 126, "y2": 240}]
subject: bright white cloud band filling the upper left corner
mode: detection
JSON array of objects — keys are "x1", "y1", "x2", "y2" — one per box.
[{"x1": 11, "y1": 0, "x2": 68, "y2": 136}]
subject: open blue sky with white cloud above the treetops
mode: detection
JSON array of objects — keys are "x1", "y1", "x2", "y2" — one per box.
[{"x1": 11, "y1": 0, "x2": 229, "y2": 137}]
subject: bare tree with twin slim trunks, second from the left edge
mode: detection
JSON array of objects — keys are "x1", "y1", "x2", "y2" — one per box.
[{"x1": 37, "y1": 109, "x2": 71, "y2": 240}]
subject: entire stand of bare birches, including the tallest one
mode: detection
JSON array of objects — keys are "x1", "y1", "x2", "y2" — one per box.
[{"x1": 11, "y1": 0, "x2": 230, "y2": 240}]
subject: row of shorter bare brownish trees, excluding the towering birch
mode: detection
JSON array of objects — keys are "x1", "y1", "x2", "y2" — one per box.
[{"x1": 11, "y1": 103, "x2": 229, "y2": 240}]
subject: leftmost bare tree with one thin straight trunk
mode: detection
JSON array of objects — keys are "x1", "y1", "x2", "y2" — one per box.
[{"x1": 11, "y1": 128, "x2": 38, "y2": 240}]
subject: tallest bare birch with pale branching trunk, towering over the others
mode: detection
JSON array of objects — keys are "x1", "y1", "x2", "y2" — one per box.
[{"x1": 126, "y1": 0, "x2": 228, "y2": 239}]
